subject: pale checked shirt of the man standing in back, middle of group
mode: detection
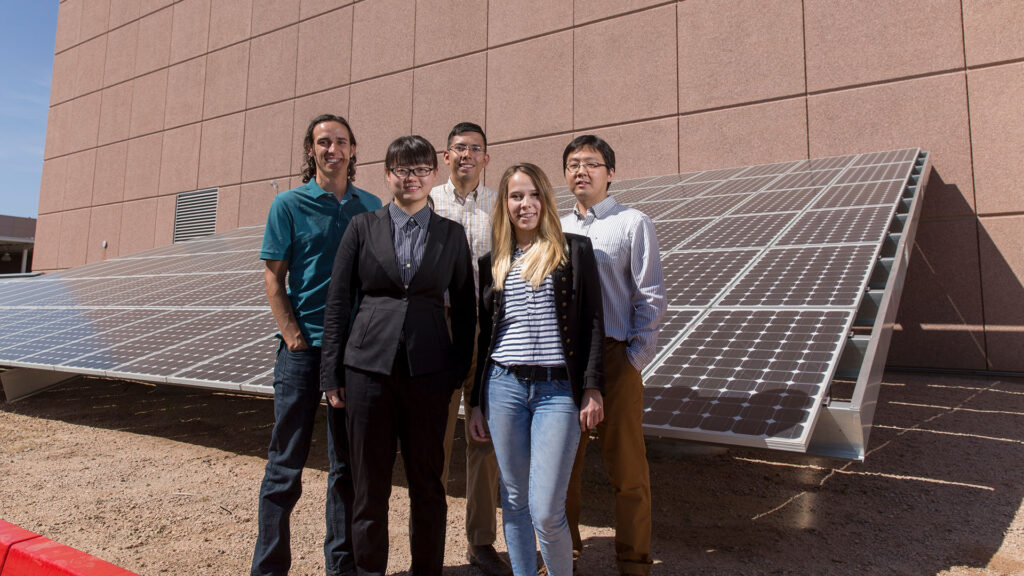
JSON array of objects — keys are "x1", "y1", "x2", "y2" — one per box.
[{"x1": 430, "y1": 178, "x2": 498, "y2": 297}]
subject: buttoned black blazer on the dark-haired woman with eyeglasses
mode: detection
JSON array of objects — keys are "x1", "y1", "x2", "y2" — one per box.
[{"x1": 321, "y1": 204, "x2": 476, "y2": 389}]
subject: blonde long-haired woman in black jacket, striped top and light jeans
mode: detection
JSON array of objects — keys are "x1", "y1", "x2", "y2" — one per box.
[{"x1": 470, "y1": 163, "x2": 604, "y2": 576}]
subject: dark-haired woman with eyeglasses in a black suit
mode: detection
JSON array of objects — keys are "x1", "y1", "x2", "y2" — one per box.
[{"x1": 321, "y1": 136, "x2": 477, "y2": 575}]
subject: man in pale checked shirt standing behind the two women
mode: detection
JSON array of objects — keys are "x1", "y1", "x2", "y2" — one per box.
[{"x1": 430, "y1": 122, "x2": 512, "y2": 576}]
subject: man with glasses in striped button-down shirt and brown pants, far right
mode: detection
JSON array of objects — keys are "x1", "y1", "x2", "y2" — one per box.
[{"x1": 562, "y1": 134, "x2": 666, "y2": 576}]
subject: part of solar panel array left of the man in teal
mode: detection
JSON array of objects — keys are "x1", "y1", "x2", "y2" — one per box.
[{"x1": 0, "y1": 227, "x2": 278, "y2": 393}]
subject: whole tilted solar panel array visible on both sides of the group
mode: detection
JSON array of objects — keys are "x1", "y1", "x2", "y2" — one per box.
[{"x1": 0, "y1": 149, "x2": 922, "y2": 450}]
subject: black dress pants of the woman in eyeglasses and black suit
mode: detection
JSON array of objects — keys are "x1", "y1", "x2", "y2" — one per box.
[{"x1": 345, "y1": 349, "x2": 453, "y2": 576}]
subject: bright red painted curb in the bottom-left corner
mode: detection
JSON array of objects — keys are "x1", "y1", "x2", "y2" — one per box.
[{"x1": 0, "y1": 520, "x2": 137, "y2": 576}]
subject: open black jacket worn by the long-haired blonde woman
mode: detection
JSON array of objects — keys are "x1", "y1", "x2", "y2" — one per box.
[{"x1": 470, "y1": 234, "x2": 604, "y2": 407}]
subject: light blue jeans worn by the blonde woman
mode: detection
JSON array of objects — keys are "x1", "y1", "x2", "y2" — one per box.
[{"x1": 485, "y1": 365, "x2": 580, "y2": 576}]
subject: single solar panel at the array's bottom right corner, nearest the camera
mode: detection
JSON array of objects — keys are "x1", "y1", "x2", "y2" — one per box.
[{"x1": 644, "y1": 310, "x2": 852, "y2": 439}]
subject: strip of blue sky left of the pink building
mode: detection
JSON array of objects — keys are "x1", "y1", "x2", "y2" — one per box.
[{"x1": 0, "y1": 0, "x2": 58, "y2": 217}]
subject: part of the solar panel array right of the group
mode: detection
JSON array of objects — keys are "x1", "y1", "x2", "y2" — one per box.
[{"x1": 557, "y1": 150, "x2": 919, "y2": 451}]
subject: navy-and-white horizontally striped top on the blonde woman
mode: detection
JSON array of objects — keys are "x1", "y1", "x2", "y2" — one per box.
[{"x1": 490, "y1": 249, "x2": 565, "y2": 366}]
